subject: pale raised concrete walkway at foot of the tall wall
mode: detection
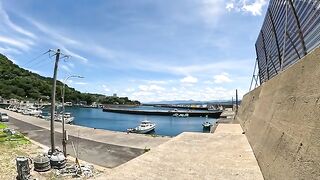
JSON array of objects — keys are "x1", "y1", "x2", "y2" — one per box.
[{"x1": 103, "y1": 124, "x2": 263, "y2": 180}]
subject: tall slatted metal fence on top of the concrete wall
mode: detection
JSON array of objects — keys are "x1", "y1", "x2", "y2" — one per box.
[{"x1": 255, "y1": 0, "x2": 320, "y2": 84}]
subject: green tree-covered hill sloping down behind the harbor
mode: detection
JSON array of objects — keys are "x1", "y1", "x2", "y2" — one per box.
[{"x1": 0, "y1": 54, "x2": 140, "y2": 105}]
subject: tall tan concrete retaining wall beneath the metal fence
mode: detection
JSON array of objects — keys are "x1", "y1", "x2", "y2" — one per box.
[{"x1": 236, "y1": 48, "x2": 320, "y2": 179}]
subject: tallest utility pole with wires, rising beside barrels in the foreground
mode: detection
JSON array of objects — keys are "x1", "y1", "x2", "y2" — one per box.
[{"x1": 50, "y1": 49, "x2": 60, "y2": 154}]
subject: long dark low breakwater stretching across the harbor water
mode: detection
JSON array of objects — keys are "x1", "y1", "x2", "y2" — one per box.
[{"x1": 103, "y1": 108, "x2": 222, "y2": 118}]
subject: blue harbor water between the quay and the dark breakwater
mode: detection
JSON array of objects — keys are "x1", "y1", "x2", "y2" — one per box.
[{"x1": 62, "y1": 107, "x2": 216, "y2": 136}]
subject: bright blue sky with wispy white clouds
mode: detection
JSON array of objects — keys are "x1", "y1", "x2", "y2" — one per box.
[{"x1": 0, "y1": 0, "x2": 267, "y2": 102}]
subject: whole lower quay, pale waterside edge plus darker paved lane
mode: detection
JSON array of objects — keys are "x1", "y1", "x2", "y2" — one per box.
[{"x1": 0, "y1": 108, "x2": 171, "y2": 168}]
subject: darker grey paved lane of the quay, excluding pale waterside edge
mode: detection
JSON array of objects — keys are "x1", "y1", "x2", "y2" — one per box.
[{"x1": 8, "y1": 118, "x2": 144, "y2": 168}]
